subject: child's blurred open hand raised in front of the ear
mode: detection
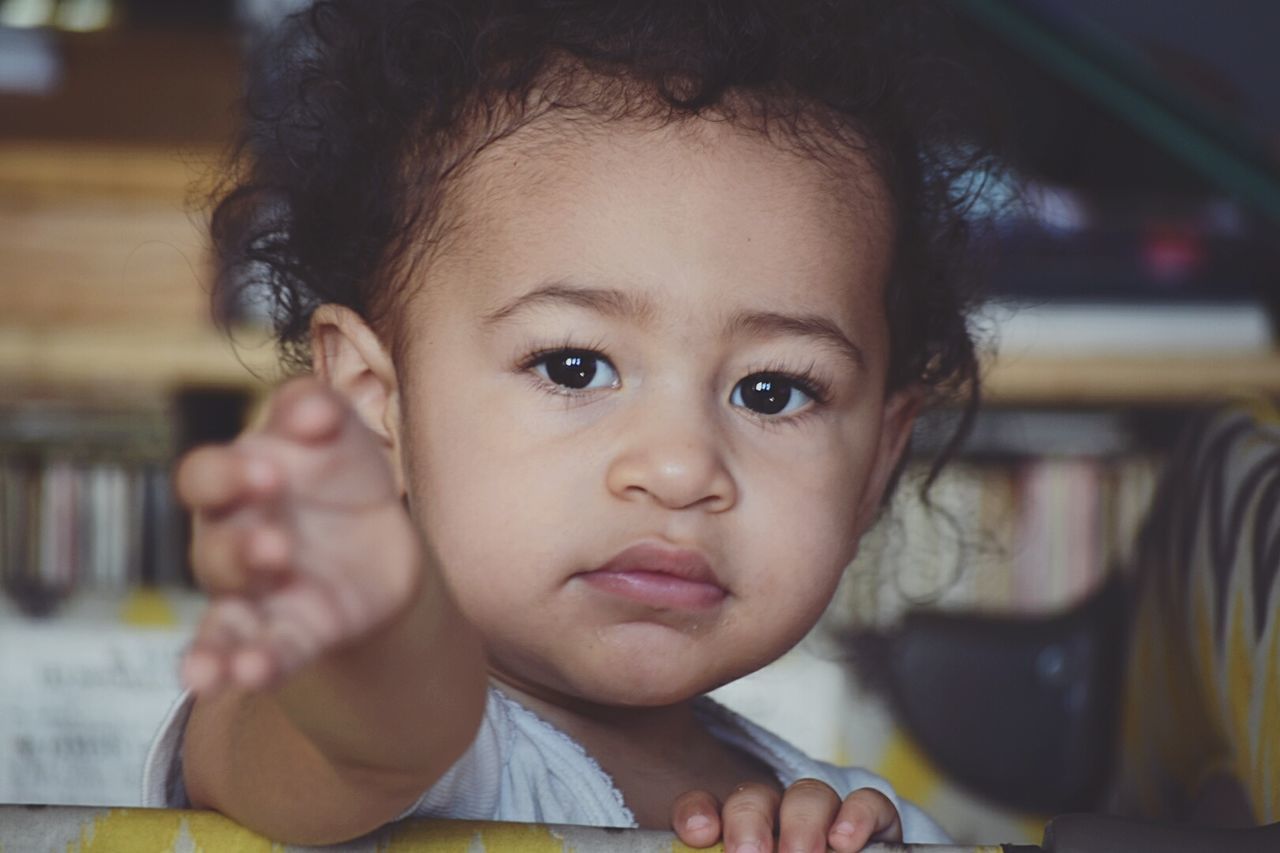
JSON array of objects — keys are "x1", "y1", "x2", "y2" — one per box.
[{"x1": 177, "y1": 379, "x2": 422, "y2": 693}]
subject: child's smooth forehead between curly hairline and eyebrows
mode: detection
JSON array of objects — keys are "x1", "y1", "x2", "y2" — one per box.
[{"x1": 409, "y1": 117, "x2": 891, "y2": 333}]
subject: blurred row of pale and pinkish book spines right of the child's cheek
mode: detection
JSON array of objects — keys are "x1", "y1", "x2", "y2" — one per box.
[{"x1": 831, "y1": 409, "x2": 1161, "y2": 628}]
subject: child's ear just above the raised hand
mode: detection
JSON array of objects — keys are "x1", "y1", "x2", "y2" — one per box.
[{"x1": 311, "y1": 305, "x2": 404, "y2": 494}]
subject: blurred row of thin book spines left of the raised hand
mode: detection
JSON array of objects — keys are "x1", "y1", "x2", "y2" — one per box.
[{"x1": 0, "y1": 402, "x2": 188, "y2": 613}]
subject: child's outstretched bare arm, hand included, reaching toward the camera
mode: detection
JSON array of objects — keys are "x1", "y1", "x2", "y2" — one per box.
[{"x1": 178, "y1": 380, "x2": 485, "y2": 844}]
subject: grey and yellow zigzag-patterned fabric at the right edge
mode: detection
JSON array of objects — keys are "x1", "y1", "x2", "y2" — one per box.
[{"x1": 1117, "y1": 403, "x2": 1280, "y2": 822}]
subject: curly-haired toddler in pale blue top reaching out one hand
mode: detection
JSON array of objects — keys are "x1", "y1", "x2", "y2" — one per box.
[{"x1": 146, "y1": 0, "x2": 977, "y2": 853}]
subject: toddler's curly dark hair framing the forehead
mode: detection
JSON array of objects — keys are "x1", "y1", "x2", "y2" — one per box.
[{"x1": 211, "y1": 0, "x2": 993, "y2": 482}]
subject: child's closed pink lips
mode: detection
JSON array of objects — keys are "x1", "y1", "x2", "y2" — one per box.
[{"x1": 579, "y1": 543, "x2": 728, "y2": 610}]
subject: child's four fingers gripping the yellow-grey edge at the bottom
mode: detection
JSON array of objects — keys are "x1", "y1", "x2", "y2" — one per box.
[{"x1": 672, "y1": 779, "x2": 902, "y2": 853}]
